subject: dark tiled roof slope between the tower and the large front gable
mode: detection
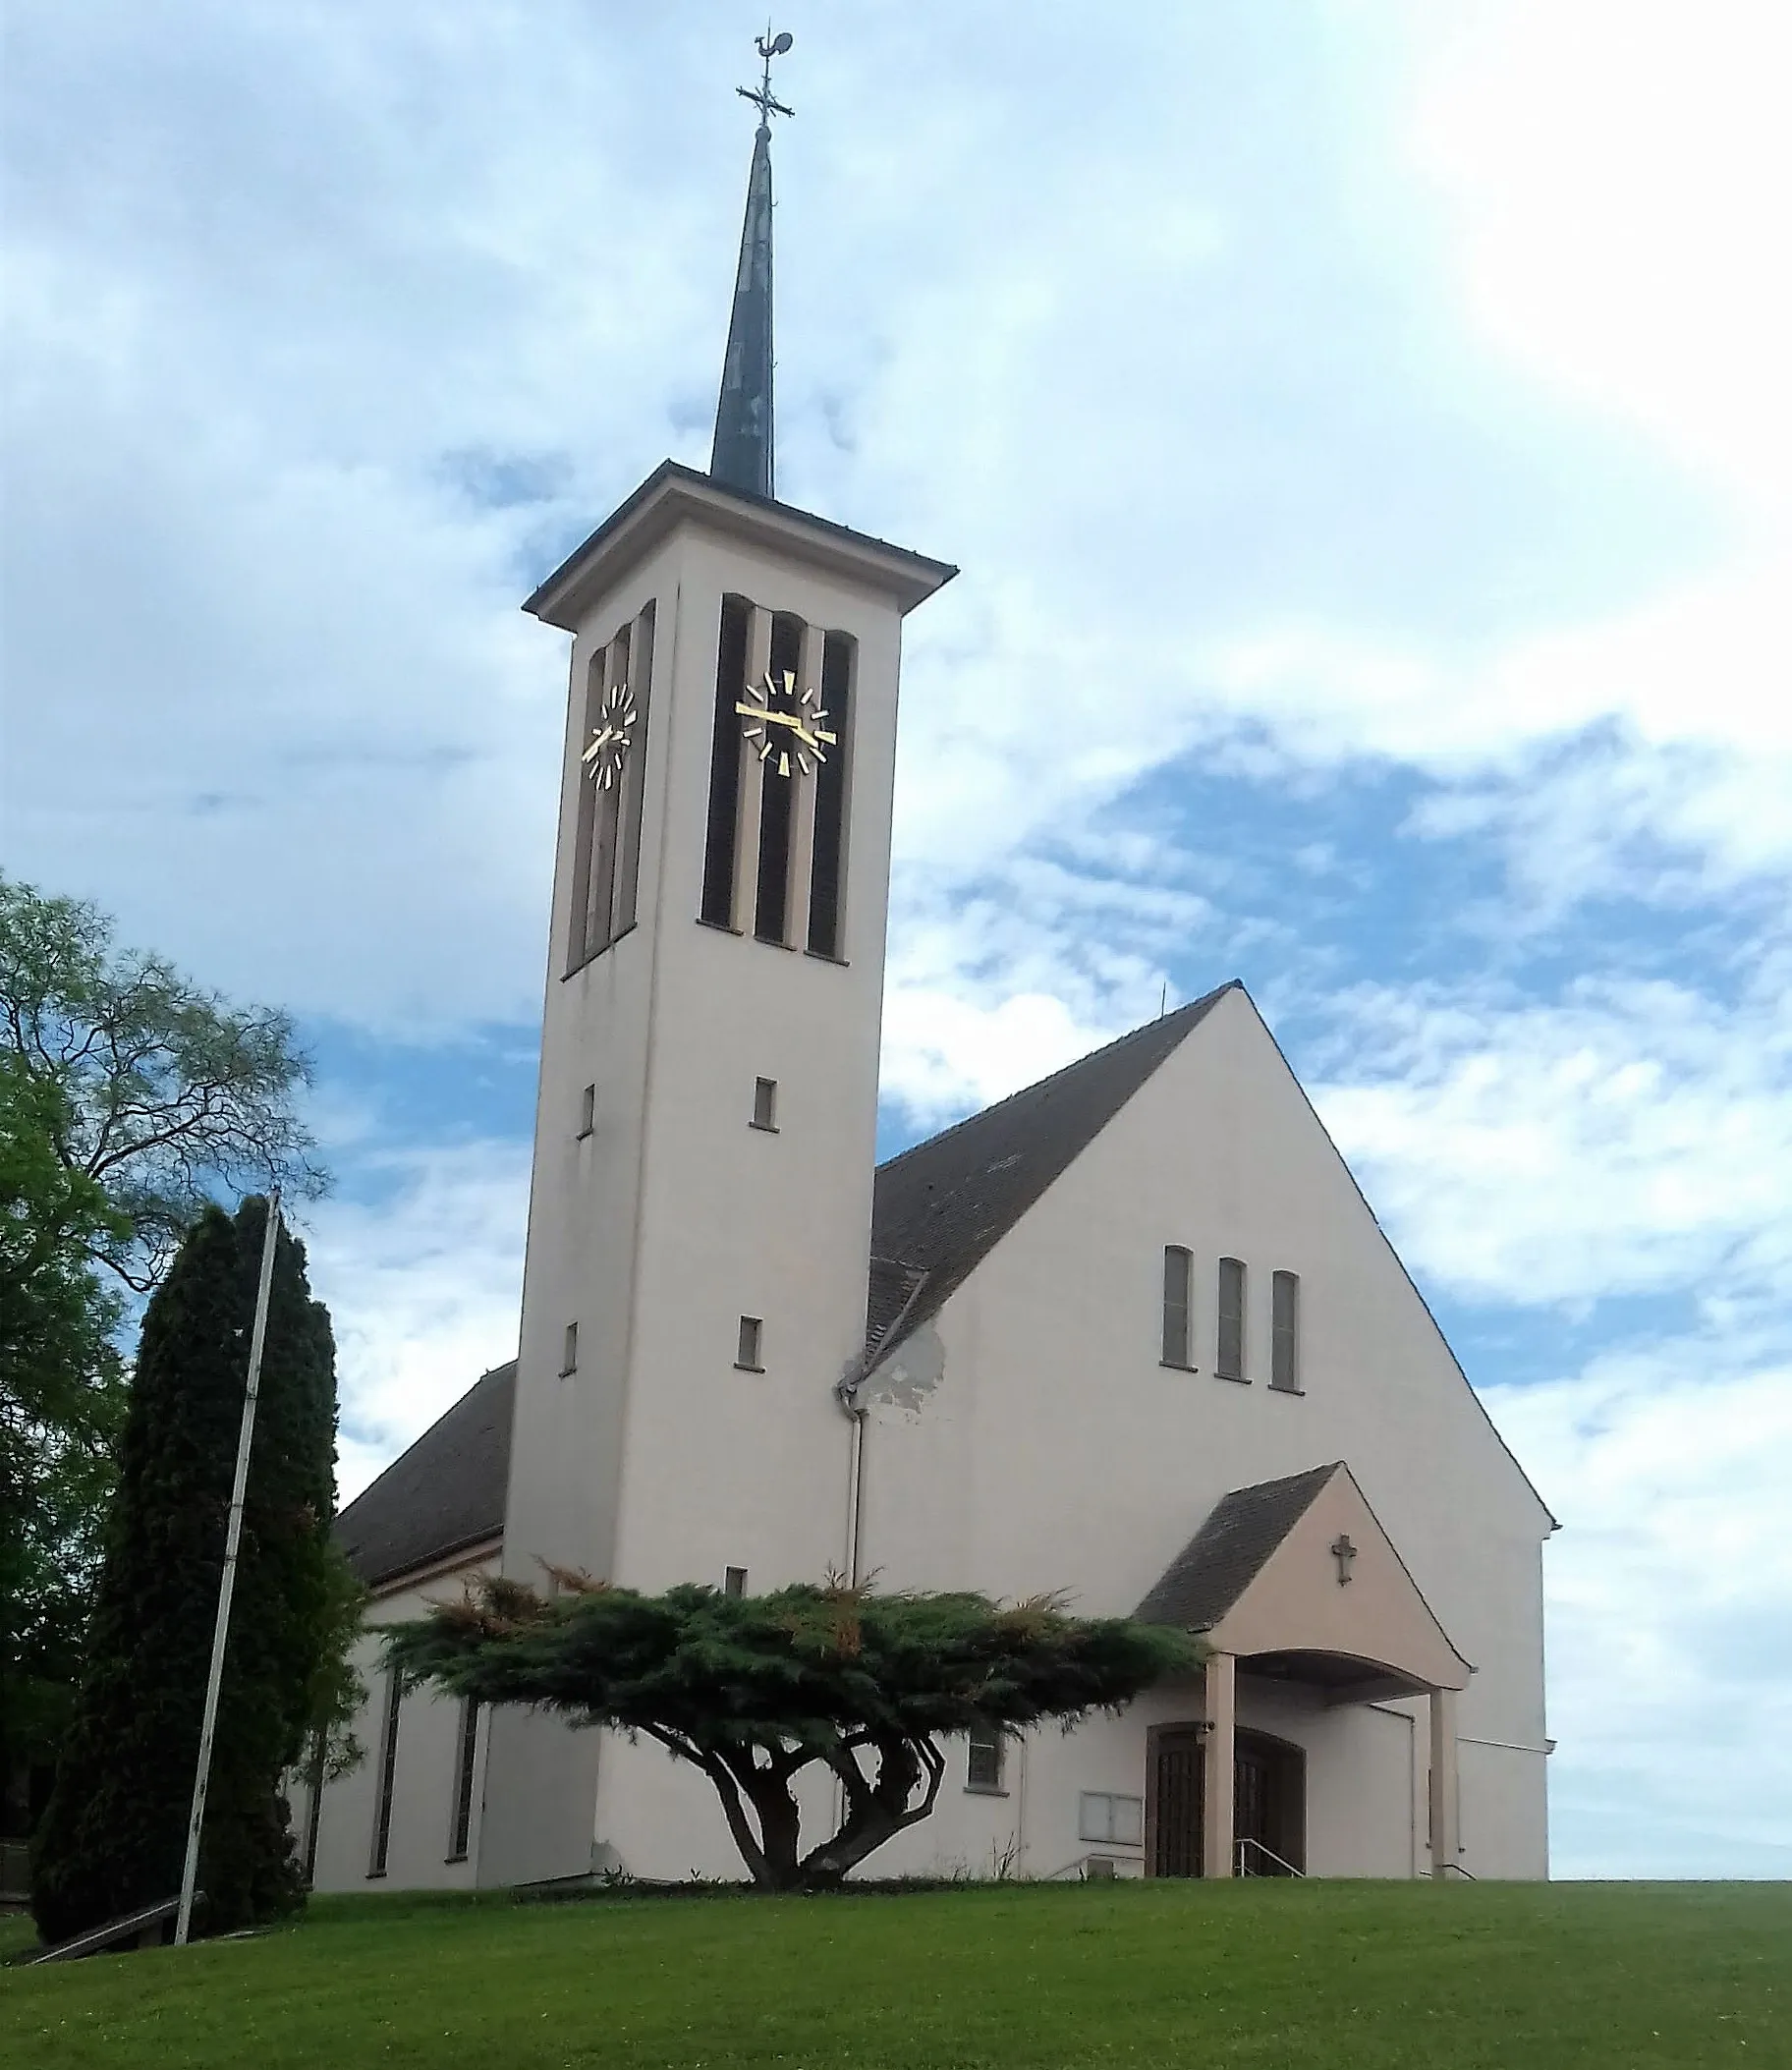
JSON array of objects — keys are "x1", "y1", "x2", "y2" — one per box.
[{"x1": 865, "y1": 979, "x2": 1238, "y2": 1360}]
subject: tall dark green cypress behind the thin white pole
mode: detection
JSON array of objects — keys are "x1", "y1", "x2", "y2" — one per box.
[{"x1": 31, "y1": 1197, "x2": 335, "y2": 1941}]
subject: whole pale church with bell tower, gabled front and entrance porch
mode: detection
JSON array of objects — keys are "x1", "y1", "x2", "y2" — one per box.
[{"x1": 294, "y1": 43, "x2": 1554, "y2": 1890}]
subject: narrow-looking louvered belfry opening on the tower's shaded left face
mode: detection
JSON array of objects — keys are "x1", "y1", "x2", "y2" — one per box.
[{"x1": 567, "y1": 602, "x2": 654, "y2": 971}]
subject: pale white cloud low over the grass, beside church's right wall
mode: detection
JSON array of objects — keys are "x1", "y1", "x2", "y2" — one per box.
[{"x1": 1485, "y1": 1337, "x2": 1792, "y2": 1877}]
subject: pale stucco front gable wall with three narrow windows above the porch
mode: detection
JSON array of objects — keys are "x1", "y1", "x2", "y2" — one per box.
[{"x1": 844, "y1": 991, "x2": 1550, "y2": 1875}]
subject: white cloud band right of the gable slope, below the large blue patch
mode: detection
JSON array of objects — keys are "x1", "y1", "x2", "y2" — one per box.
[{"x1": 1310, "y1": 979, "x2": 1792, "y2": 1307}]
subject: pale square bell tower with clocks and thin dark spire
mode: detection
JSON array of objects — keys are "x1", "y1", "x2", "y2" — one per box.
[{"x1": 478, "y1": 35, "x2": 954, "y2": 1883}]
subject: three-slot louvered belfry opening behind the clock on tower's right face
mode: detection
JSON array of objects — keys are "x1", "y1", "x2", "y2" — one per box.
[{"x1": 700, "y1": 596, "x2": 857, "y2": 959}]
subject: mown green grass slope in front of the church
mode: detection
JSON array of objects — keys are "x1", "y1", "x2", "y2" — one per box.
[{"x1": 0, "y1": 1881, "x2": 1792, "y2": 2070}]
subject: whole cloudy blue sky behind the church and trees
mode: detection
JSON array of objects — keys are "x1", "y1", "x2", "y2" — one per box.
[{"x1": 0, "y1": 0, "x2": 1792, "y2": 1875}]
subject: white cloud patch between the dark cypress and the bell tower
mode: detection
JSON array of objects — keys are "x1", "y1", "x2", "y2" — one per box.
[{"x1": 303, "y1": 1143, "x2": 530, "y2": 1503}]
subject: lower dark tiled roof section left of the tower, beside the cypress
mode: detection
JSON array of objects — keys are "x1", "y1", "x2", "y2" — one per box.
[{"x1": 333, "y1": 1360, "x2": 518, "y2": 1588}]
